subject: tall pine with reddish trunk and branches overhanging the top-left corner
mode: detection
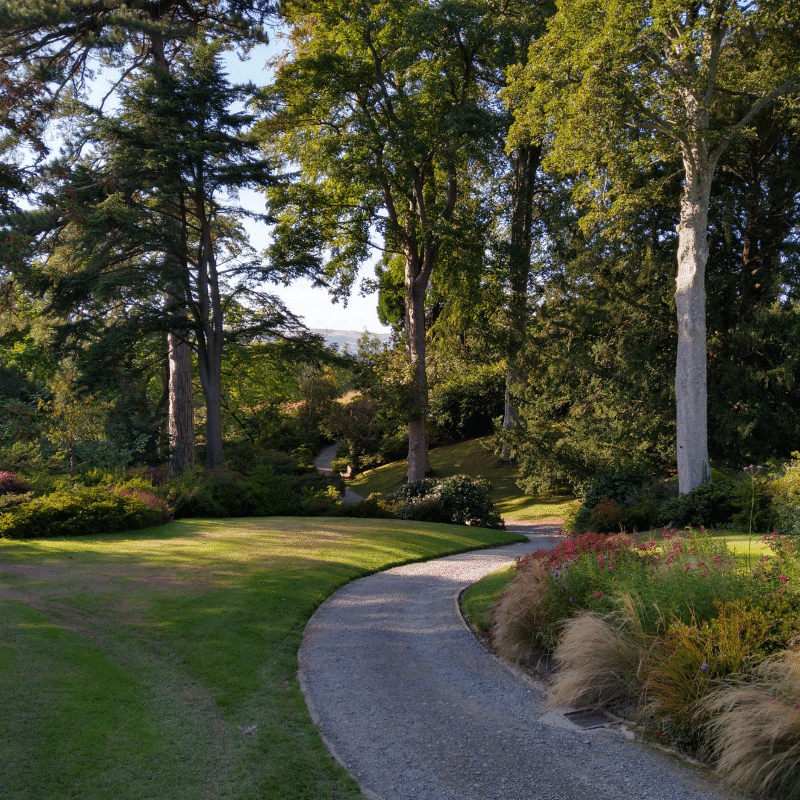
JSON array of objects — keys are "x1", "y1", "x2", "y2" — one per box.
[{"x1": 0, "y1": 0, "x2": 274, "y2": 473}]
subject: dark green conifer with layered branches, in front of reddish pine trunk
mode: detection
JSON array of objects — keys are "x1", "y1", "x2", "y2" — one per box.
[{"x1": 10, "y1": 42, "x2": 298, "y2": 467}]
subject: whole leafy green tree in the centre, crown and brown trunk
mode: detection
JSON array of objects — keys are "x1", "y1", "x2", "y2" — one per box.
[{"x1": 264, "y1": 0, "x2": 491, "y2": 481}]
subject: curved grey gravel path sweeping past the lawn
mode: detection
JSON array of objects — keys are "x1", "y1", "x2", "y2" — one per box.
[{"x1": 298, "y1": 523, "x2": 734, "y2": 800}]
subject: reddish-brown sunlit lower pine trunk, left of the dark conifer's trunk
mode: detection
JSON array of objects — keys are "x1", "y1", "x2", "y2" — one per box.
[{"x1": 167, "y1": 333, "x2": 196, "y2": 476}]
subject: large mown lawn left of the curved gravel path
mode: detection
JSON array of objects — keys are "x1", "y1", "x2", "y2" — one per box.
[{"x1": 0, "y1": 518, "x2": 517, "y2": 800}]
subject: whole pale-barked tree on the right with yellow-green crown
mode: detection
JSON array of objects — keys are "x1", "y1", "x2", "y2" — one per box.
[{"x1": 511, "y1": 0, "x2": 800, "y2": 492}]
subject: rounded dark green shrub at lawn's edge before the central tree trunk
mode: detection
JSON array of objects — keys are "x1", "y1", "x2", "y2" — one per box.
[{"x1": 395, "y1": 475, "x2": 503, "y2": 528}]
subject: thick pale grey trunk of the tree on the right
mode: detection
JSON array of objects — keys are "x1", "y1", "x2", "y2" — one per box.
[{"x1": 675, "y1": 153, "x2": 714, "y2": 494}]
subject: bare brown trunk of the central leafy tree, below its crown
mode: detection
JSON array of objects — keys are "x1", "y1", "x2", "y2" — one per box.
[{"x1": 406, "y1": 265, "x2": 430, "y2": 483}]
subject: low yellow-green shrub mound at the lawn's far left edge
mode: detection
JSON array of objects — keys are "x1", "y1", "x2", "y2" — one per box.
[{"x1": 0, "y1": 488, "x2": 163, "y2": 539}]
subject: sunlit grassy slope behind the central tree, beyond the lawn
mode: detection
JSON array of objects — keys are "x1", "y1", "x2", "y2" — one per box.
[{"x1": 350, "y1": 437, "x2": 574, "y2": 522}]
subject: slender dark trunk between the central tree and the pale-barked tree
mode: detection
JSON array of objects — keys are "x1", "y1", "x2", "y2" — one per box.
[{"x1": 500, "y1": 145, "x2": 541, "y2": 462}]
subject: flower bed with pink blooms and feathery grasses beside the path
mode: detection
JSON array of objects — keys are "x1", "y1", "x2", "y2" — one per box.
[{"x1": 493, "y1": 530, "x2": 800, "y2": 799}]
